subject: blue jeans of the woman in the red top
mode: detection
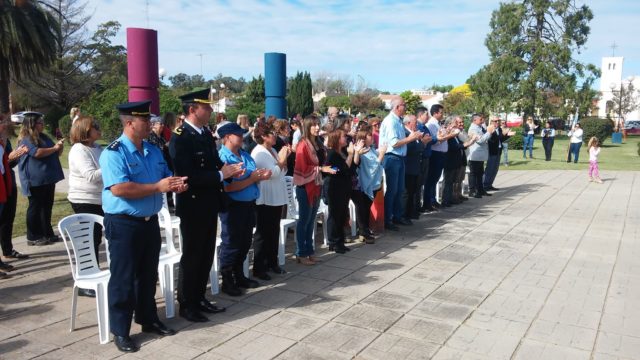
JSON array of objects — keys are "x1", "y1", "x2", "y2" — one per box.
[{"x1": 296, "y1": 186, "x2": 320, "y2": 257}]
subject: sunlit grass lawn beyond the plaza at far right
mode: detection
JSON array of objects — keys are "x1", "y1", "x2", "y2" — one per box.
[{"x1": 501, "y1": 136, "x2": 640, "y2": 172}]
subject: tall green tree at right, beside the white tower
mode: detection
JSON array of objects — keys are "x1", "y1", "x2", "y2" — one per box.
[{"x1": 482, "y1": 0, "x2": 597, "y2": 117}]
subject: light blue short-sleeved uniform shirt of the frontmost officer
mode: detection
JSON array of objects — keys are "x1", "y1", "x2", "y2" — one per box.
[{"x1": 100, "y1": 134, "x2": 171, "y2": 217}]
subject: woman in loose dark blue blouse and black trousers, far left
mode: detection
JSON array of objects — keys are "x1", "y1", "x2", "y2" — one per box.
[{"x1": 18, "y1": 112, "x2": 64, "y2": 246}]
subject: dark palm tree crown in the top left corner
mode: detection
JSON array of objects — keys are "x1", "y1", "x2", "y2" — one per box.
[{"x1": 0, "y1": 0, "x2": 59, "y2": 113}]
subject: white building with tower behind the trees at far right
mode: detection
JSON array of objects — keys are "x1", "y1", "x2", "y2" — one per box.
[{"x1": 598, "y1": 56, "x2": 640, "y2": 120}]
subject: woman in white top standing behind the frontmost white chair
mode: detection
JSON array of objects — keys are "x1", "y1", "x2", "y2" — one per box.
[{"x1": 67, "y1": 116, "x2": 104, "y2": 296}]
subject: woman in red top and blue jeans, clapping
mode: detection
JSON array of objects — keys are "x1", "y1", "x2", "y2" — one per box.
[{"x1": 293, "y1": 115, "x2": 336, "y2": 265}]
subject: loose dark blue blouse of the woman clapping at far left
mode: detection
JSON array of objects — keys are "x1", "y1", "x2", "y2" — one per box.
[{"x1": 18, "y1": 134, "x2": 64, "y2": 196}]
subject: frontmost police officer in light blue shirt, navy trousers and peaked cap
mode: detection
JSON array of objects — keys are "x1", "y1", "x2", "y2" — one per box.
[{"x1": 100, "y1": 101, "x2": 187, "y2": 352}]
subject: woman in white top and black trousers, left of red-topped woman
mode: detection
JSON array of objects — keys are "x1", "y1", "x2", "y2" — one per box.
[{"x1": 251, "y1": 122, "x2": 291, "y2": 280}]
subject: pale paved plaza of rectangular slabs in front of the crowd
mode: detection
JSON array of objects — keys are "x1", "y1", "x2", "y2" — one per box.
[{"x1": 0, "y1": 169, "x2": 640, "y2": 360}]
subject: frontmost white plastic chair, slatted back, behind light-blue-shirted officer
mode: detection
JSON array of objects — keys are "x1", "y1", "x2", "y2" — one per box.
[{"x1": 58, "y1": 214, "x2": 111, "y2": 344}]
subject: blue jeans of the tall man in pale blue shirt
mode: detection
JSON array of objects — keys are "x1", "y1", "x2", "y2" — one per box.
[{"x1": 382, "y1": 155, "x2": 404, "y2": 224}]
